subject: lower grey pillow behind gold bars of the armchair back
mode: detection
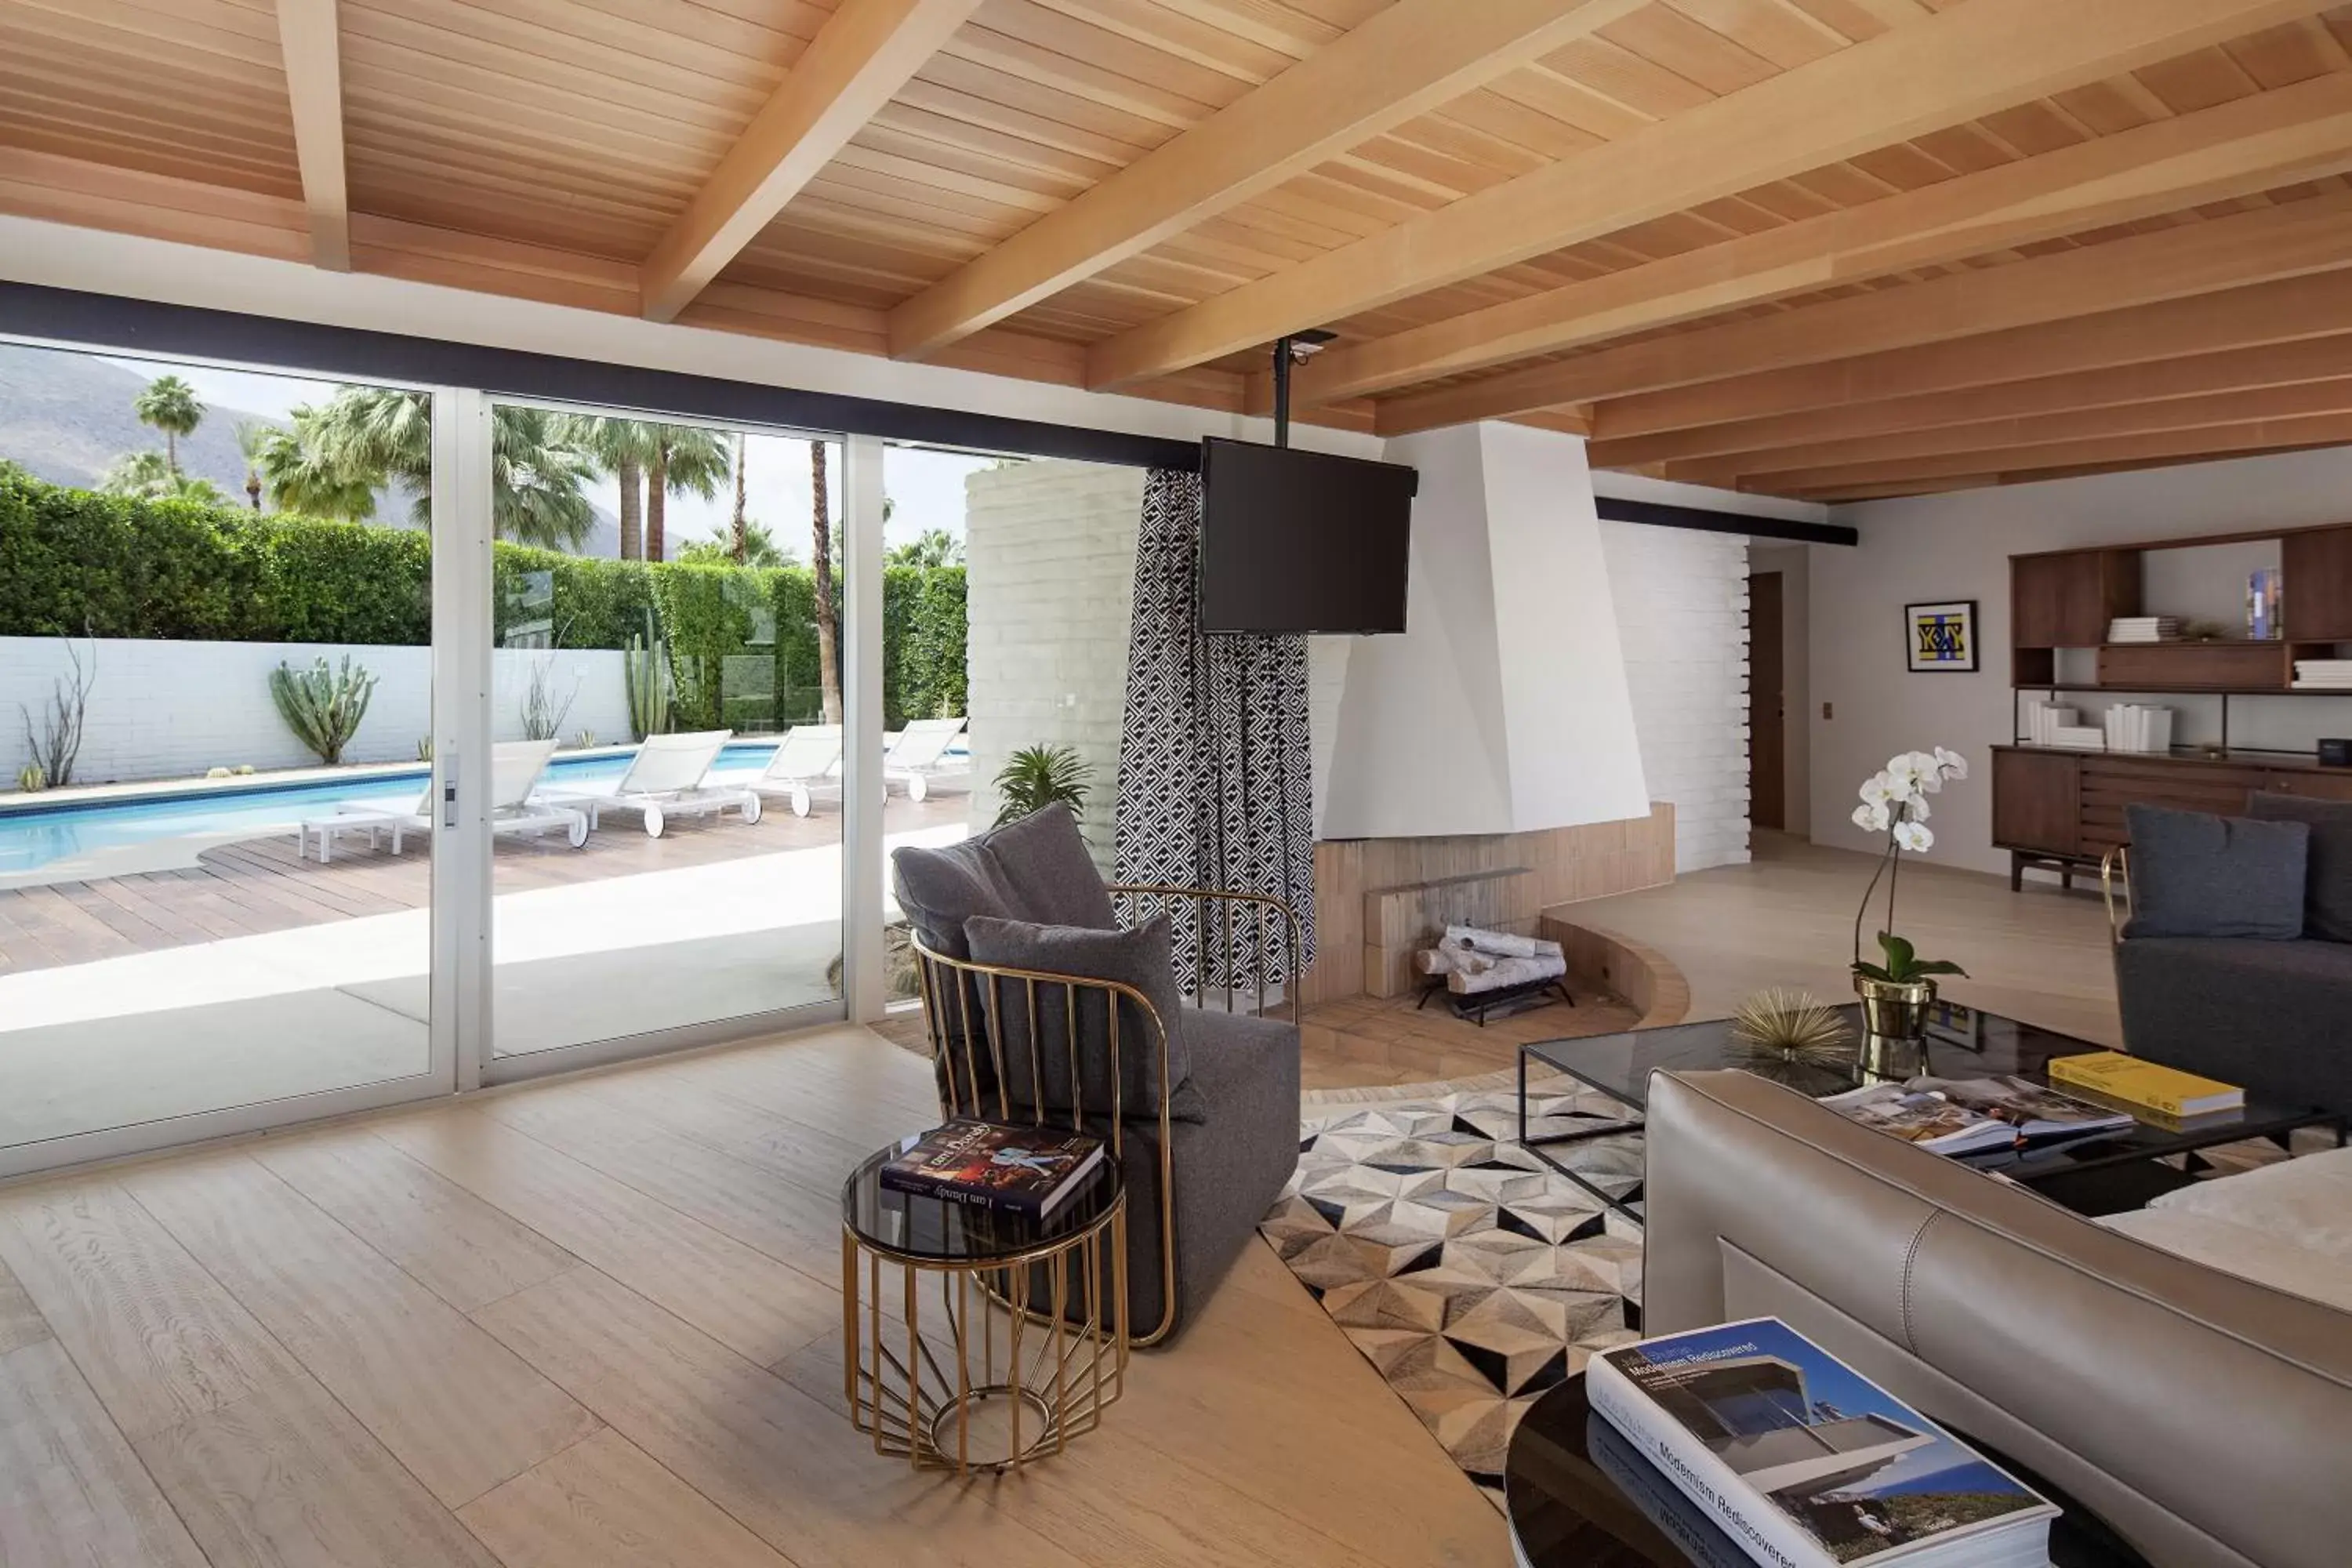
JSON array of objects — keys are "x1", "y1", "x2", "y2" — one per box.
[{"x1": 964, "y1": 914, "x2": 1207, "y2": 1121}]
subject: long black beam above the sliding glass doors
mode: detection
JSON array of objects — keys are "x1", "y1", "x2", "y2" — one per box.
[{"x1": 0, "y1": 282, "x2": 1200, "y2": 473}]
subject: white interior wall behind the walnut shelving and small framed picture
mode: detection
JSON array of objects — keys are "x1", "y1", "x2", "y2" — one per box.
[{"x1": 1811, "y1": 447, "x2": 2352, "y2": 869}]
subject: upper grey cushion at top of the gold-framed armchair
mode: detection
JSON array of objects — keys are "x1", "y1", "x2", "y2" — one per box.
[{"x1": 891, "y1": 801, "x2": 1120, "y2": 959}]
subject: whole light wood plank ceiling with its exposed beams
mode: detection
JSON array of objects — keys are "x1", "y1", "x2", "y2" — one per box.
[{"x1": 0, "y1": 0, "x2": 2352, "y2": 501}]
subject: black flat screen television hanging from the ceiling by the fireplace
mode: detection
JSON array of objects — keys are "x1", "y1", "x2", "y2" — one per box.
[{"x1": 1200, "y1": 437, "x2": 1418, "y2": 635}]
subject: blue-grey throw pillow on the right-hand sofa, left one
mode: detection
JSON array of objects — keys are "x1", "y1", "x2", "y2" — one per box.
[{"x1": 2124, "y1": 806, "x2": 2312, "y2": 942}]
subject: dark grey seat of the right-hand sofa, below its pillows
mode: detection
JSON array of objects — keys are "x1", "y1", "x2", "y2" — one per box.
[{"x1": 2114, "y1": 928, "x2": 2352, "y2": 1112}]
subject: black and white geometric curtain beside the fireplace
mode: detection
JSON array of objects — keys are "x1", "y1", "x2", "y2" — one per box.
[{"x1": 1117, "y1": 468, "x2": 1315, "y2": 992}]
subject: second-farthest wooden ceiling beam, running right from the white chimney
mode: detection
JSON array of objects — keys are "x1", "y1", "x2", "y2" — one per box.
[{"x1": 1590, "y1": 333, "x2": 2352, "y2": 468}]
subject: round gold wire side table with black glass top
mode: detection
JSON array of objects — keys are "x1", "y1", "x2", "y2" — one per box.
[{"x1": 842, "y1": 1145, "x2": 1127, "y2": 1474}]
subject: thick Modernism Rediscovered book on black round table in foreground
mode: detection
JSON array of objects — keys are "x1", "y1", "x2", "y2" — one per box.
[{"x1": 1585, "y1": 1319, "x2": 2058, "y2": 1568}]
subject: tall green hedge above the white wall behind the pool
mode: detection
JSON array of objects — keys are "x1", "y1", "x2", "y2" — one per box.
[{"x1": 0, "y1": 463, "x2": 967, "y2": 729}]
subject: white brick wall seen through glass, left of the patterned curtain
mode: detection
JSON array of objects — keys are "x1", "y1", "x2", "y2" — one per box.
[{"x1": 964, "y1": 461, "x2": 1143, "y2": 872}]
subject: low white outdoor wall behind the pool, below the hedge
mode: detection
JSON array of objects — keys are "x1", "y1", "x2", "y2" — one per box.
[{"x1": 0, "y1": 637, "x2": 630, "y2": 787}]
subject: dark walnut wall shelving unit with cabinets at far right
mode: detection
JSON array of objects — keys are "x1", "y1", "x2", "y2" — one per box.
[{"x1": 1992, "y1": 524, "x2": 2352, "y2": 886}]
